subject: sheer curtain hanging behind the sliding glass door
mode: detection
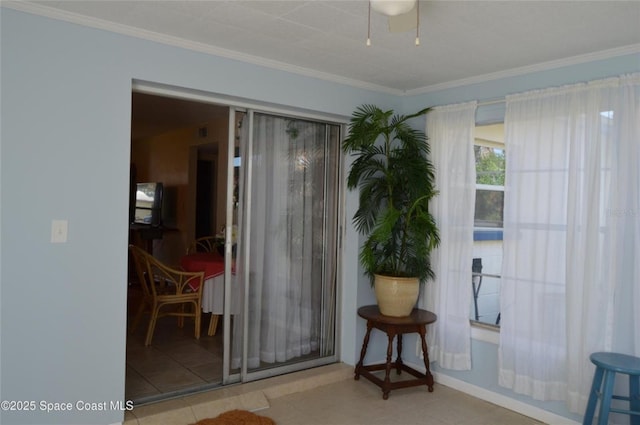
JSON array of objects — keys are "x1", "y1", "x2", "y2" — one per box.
[{"x1": 232, "y1": 113, "x2": 325, "y2": 369}]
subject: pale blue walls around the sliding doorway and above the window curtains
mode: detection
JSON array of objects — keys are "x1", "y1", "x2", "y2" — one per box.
[{"x1": 0, "y1": 4, "x2": 640, "y2": 424}]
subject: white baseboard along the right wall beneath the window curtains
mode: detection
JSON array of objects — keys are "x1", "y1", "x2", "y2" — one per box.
[{"x1": 409, "y1": 364, "x2": 580, "y2": 425}]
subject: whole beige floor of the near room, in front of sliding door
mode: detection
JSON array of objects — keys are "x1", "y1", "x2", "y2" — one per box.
[{"x1": 124, "y1": 364, "x2": 540, "y2": 425}]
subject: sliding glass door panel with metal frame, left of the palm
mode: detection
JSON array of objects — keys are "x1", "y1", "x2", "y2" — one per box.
[{"x1": 227, "y1": 111, "x2": 340, "y2": 381}]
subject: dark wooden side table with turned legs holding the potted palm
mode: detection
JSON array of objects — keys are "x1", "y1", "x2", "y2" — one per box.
[{"x1": 354, "y1": 305, "x2": 438, "y2": 400}]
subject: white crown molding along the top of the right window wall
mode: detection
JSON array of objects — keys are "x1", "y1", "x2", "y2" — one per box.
[{"x1": 403, "y1": 44, "x2": 640, "y2": 96}]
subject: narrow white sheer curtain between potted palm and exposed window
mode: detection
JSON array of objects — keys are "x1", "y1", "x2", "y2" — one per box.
[{"x1": 420, "y1": 102, "x2": 476, "y2": 370}]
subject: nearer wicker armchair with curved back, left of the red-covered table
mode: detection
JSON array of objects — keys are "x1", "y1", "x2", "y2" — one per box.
[{"x1": 129, "y1": 245, "x2": 204, "y2": 346}]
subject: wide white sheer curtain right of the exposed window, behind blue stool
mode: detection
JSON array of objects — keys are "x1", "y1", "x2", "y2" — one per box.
[{"x1": 499, "y1": 74, "x2": 640, "y2": 412}]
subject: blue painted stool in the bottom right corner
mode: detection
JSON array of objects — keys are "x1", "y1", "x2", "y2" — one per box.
[{"x1": 582, "y1": 353, "x2": 640, "y2": 425}]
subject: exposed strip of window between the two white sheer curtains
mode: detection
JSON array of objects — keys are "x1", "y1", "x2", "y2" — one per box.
[{"x1": 470, "y1": 123, "x2": 506, "y2": 325}]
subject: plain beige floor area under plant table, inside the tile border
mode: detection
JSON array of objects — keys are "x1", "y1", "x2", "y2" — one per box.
[{"x1": 256, "y1": 372, "x2": 539, "y2": 425}]
